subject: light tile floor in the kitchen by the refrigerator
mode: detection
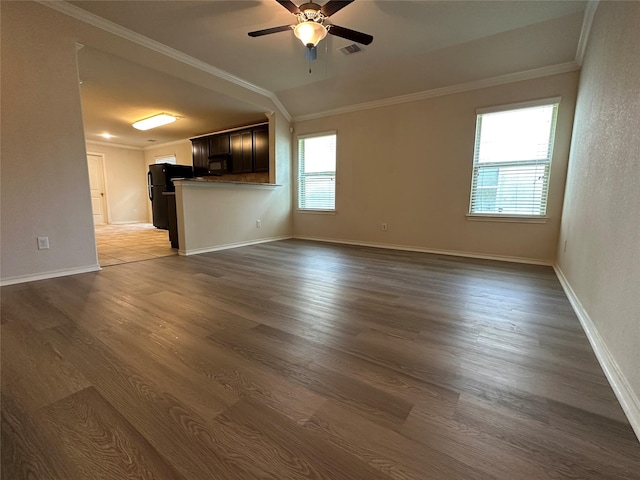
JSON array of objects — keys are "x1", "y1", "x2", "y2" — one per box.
[{"x1": 95, "y1": 223, "x2": 178, "y2": 267}]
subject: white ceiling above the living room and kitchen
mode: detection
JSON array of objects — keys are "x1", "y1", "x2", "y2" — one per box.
[{"x1": 61, "y1": 0, "x2": 586, "y2": 146}]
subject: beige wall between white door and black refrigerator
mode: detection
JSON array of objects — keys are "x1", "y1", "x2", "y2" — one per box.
[{"x1": 87, "y1": 142, "x2": 151, "y2": 223}]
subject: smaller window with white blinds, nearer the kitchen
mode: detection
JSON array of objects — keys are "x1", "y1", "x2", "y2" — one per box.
[{"x1": 298, "y1": 132, "x2": 336, "y2": 210}]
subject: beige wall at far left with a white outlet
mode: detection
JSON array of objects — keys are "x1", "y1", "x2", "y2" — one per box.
[{"x1": 0, "y1": 2, "x2": 98, "y2": 284}]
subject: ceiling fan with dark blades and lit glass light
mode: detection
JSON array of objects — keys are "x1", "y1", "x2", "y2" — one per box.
[{"x1": 249, "y1": 0, "x2": 373, "y2": 59}]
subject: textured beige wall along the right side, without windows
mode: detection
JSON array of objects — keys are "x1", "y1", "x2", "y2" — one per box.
[{"x1": 558, "y1": 2, "x2": 640, "y2": 435}]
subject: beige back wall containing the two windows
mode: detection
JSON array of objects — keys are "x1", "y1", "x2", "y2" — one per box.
[{"x1": 294, "y1": 72, "x2": 578, "y2": 264}]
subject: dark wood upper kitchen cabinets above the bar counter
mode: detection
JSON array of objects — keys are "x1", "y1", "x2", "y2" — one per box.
[{"x1": 191, "y1": 123, "x2": 269, "y2": 176}]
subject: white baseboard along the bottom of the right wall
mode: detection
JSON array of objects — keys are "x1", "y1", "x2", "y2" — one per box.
[{"x1": 553, "y1": 265, "x2": 640, "y2": 440}]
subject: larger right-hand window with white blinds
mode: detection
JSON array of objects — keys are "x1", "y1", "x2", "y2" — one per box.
[{"x1": 469, "y1": 99, "x2": 559, "y2": 217}]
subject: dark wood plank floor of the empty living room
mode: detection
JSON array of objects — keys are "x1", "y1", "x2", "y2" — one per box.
[{"x1": 1, "y1": 240, "x2": 640, "y2": 480}]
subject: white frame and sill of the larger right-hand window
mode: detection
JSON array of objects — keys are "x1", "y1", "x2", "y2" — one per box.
[{"x1": 467, "y1": 97, "x2": 562, "y2": 223}]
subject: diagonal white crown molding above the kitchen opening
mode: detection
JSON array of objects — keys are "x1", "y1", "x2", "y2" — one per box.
[{"x1": 36, "y1": 0, "x2": 291, "y2": 121}]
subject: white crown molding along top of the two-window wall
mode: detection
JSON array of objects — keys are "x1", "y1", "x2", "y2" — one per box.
[{"x1": 293, "y1": 62, "x2": 580, "y2": 122}]
